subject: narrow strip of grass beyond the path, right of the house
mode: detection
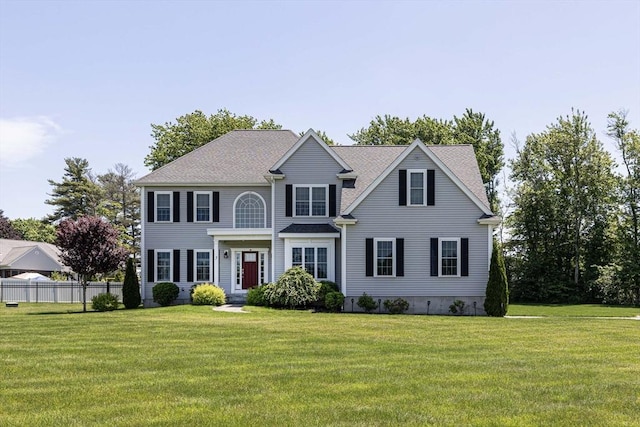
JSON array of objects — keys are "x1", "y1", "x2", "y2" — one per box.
[{"x1": 507, "y1": 304, "x2": 640, "y2": 317}]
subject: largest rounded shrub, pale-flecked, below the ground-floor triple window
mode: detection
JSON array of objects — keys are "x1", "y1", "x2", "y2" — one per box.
[{"x1": 264, "y1": 267, "x2": 320, "y2": 308}]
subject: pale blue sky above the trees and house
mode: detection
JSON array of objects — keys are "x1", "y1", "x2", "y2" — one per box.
[{"x1": 0, "y1": 0, "x2": 640, "y2": 219}]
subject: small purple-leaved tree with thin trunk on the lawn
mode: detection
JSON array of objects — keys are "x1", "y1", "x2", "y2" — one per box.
[{"x1": 56, "y1": 216, "x2": 127, "y2": 311}]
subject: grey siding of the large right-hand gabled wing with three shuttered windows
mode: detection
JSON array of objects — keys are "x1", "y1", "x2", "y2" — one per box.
[{"x1": 347, "y1": 145, "x2": 488, "y2": 297}]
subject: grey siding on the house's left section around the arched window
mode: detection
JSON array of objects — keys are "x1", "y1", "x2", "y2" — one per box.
[{"x1": 141, "y1": 186, "x2": 271, "y2": 300}]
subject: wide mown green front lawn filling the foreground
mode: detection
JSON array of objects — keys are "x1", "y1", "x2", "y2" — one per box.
[{"x1": 0, "y1": 303, "x2": 640, "y2": 426}]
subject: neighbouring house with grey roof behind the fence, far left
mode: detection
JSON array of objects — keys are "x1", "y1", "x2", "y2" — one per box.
[{"x1": 0, "y1": 239, "x2": 70, "y2": 278}]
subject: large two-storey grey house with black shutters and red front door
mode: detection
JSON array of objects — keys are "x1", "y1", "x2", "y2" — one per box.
[{"x1": 137, "y1": 130, "x2": 500, "y2": 314}]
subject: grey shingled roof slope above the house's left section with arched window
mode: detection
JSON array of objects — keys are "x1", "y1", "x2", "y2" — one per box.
[{"x1": 135, "y1": 130, "x2": 299, "y2": 186}]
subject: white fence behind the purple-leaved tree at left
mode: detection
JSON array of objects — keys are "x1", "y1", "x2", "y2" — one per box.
[{"x1": 0, "y1": 279, "x2": 122, "y2": 303}]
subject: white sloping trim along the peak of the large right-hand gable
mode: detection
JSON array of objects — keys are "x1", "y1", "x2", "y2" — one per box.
[{"x1": 342, "y1": 139, "x2": 493, "y2": 215}]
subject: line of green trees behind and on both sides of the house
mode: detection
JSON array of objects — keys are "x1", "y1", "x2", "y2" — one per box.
[{"x1": 0, "y1": 109, "x2": 640, "y2": 304}]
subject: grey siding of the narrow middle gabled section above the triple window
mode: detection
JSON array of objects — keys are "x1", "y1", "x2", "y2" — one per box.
[{"x1": 274, "y1": 139, "x2": 342, "y2": 281}]
